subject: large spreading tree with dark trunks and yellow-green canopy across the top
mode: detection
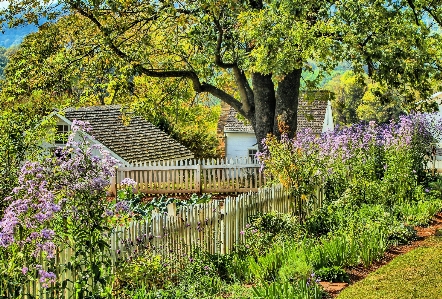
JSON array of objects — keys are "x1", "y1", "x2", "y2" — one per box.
[{"x1": 0, "y1": 0, "x2": 442, "y2": 148}]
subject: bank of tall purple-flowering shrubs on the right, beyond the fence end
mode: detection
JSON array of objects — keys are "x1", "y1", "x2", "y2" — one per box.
[{"x1": 258, "y1": 114, "x2": 442, "y2": 204}]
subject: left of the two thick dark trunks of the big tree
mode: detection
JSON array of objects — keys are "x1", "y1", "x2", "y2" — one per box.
[{"x1": 252, "y1": 73, "x2": 276, "y2": 150}]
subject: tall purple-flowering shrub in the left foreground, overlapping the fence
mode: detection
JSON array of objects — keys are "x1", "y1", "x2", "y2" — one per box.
[{"x1": 0, "y1": 121, "x2": 118, "y2": 298}]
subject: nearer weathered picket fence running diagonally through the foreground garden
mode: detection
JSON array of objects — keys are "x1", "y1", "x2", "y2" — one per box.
[{"x1": 9, "y1": 185, "x2": 324, "y2": 299}]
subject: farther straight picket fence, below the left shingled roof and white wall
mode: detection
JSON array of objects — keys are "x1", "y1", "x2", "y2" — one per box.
[{"x1": 110, "y1": 158, "x2": 265, "y2": 194}]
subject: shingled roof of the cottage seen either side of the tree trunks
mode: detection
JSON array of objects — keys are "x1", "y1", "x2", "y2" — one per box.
[{"x1": 224, "y1": 98, "x2": 327, "y2": 134}]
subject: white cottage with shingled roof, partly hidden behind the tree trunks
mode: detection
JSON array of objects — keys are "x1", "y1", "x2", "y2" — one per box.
[{"x1": 218, "y1": 99, "x2": 334, "y2": 160}]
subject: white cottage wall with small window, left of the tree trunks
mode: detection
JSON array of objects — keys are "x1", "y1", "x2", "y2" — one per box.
[{"x1": 225, "y1": 132, "x2": 258, "y2": 159}]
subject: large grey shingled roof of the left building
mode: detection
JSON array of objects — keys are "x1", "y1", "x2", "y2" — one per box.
[{"x1": 64, "y1": 105, "x2": 194, "y2": 163}]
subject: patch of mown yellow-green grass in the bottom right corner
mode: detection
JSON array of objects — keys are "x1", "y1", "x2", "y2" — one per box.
[{"x1": 338, "y1": 237, "x2": 442, "y2": 299}]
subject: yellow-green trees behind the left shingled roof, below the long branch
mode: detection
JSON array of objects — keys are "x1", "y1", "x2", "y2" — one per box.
[{"x1": 3, "y1": 15, "x2": 219, "y2": 158}]
